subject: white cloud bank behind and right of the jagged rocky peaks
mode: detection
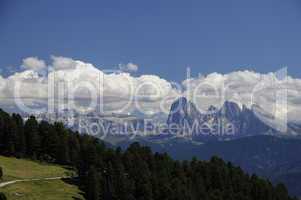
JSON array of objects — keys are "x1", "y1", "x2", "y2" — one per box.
[{"x1": 182, "y1": 69, "x2": 301, "y2": 124}]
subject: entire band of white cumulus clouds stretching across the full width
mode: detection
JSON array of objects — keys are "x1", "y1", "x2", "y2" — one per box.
[{"x1": 0, "y1": 56, "x2": 301, "y2": 126}]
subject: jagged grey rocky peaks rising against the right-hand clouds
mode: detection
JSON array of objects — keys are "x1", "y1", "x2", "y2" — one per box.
[{"x1": 167, "y1": 97, "x2": 273, "y2": 136}]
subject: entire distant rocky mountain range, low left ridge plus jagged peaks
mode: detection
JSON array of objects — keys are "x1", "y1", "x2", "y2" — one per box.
[{"x1": 32, "y1": 97, "x2": 301, "y2": 140}]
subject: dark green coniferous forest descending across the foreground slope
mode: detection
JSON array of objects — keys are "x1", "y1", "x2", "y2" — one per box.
[{"x1": 0, "y1": 110, "x2": 295, "y2": 200}]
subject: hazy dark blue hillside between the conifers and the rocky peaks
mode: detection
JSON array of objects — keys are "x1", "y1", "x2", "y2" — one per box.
[{"x1": 115, "y1": 135, "x2": 301, "y2": 197}]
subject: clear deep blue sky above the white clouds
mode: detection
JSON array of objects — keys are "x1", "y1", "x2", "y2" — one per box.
[{"x1": 0, "y1": 0, "x2": 301, "y2": 81}]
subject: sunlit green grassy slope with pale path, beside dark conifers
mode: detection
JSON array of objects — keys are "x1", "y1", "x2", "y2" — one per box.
[{"x1": 0, "y1": 156, "x2": 83, "y2": 200}]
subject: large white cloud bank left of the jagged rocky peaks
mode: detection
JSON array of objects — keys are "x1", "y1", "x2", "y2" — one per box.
[{"x1": 0, "y1": 56, "x2": 176, "y2": 113}]
